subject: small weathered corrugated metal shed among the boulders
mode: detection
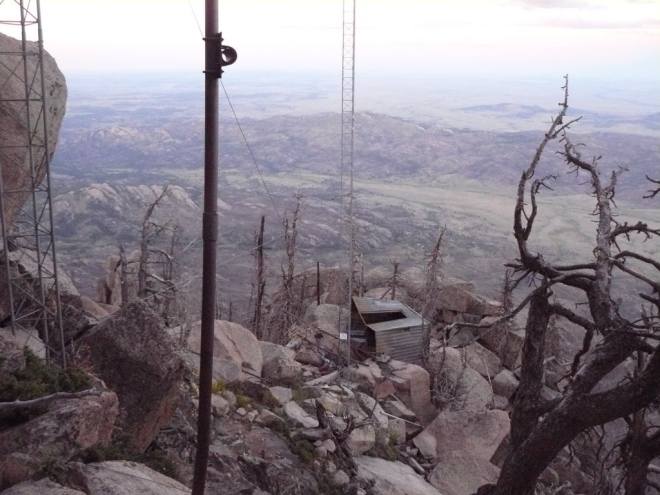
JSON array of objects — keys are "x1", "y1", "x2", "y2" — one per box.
[{"x1": 351, "y1": 297, "x2": 424, "y2": 363}]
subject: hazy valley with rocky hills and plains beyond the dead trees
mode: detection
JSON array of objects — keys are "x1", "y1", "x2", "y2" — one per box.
[{"x1": 47, "y1": 75, "x2": 660, "y2": 320}]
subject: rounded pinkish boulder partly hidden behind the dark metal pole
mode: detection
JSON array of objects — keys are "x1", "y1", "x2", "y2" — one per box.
[{"x1": 188, "y1": 320, "x2": 263, "y2": 382}]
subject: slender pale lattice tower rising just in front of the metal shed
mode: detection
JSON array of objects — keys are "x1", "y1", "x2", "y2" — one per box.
[{"x1": 340, "y1": 0, "x2": 357, "y2": 364}]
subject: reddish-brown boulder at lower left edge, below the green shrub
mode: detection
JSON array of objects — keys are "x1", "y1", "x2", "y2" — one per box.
[{"x1": 0, "y1": 390, "x2": 119, "y2": 489}]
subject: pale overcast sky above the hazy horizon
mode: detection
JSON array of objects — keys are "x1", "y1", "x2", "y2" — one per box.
[{"x1": 25, "y1": 0, "x2": 660, "y2": 79}]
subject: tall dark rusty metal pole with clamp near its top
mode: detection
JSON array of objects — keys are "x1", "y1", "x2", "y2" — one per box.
[{"x1": 192, "y1": 0, "x2": 220, "y2": 495}]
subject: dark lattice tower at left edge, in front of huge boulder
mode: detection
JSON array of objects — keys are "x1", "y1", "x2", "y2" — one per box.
[{"x1": 0, "y1": 0, "x2": 66, "y2": 366}]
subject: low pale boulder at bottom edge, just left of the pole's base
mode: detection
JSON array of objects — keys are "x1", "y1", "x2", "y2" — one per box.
[{"x1": 66, "y1": 461, "x2": 190, "y2": 495}]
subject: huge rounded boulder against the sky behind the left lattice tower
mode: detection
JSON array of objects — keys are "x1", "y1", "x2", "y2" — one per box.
[{"x1": 0, "y1": 33, "x2": 67, "y2": 229}]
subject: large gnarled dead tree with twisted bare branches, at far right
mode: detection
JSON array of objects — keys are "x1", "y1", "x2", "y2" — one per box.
[{"x1": 479, "y1": 75, "x2": 660, "y2": 495}]
